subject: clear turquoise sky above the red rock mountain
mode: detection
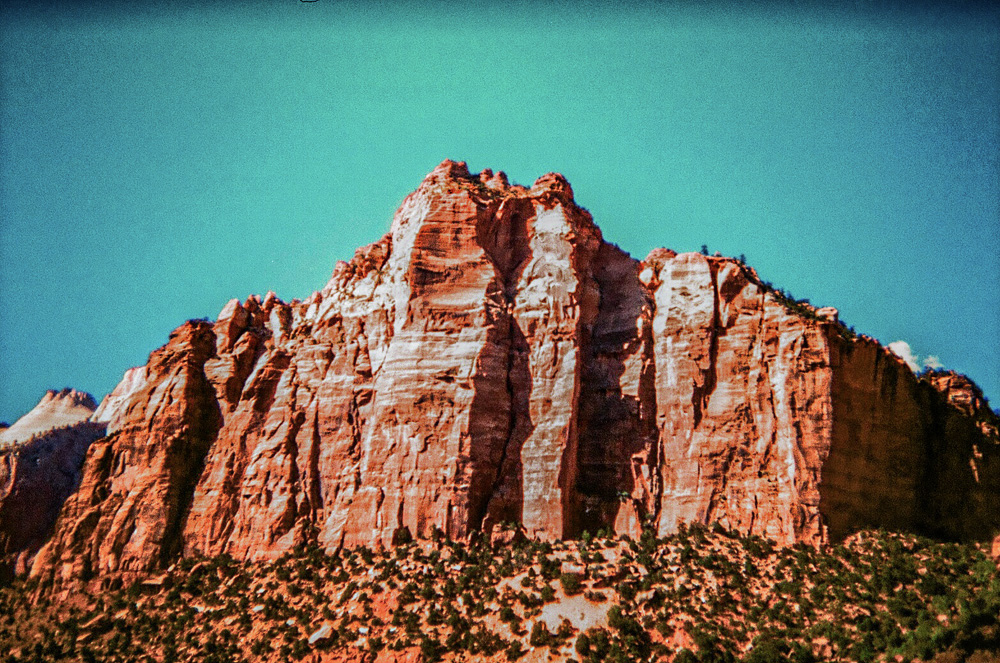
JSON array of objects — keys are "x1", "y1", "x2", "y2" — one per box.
[{"x1": 0, "y1": 0, "x2": 1000, "y2": 422}]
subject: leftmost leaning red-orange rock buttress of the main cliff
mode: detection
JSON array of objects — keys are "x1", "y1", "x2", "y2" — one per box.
[{"x1": 33, "y1": 322, "x2": 219, "y2": 581}]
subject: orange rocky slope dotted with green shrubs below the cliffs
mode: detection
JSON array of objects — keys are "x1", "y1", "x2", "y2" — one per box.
[{"x1": 0, "y1": 526, "x2": 1000, "y2": 663}]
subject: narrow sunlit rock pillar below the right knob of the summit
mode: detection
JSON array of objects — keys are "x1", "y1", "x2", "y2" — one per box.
[{"x1": 512, "y1": 175, "x2": 601, "y2": 537}]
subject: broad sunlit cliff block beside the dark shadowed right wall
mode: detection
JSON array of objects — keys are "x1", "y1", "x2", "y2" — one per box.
[{"x1": 642, "y1": 253, "x2": 832, "y2": 543}]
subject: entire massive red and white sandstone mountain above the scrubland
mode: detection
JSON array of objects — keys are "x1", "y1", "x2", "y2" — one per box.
[{"x1": 23, "y1": 161, "x2": 1000, "y2": 580}]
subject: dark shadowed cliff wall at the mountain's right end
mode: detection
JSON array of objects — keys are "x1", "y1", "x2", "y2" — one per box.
[{"x1": 819, "y1": 332, "x2": 1000, "y2": 542}]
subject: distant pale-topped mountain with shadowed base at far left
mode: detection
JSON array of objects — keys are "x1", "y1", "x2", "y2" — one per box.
[{"x1": 0, "y1": 389, "x2": 105, "y2": 573}]
